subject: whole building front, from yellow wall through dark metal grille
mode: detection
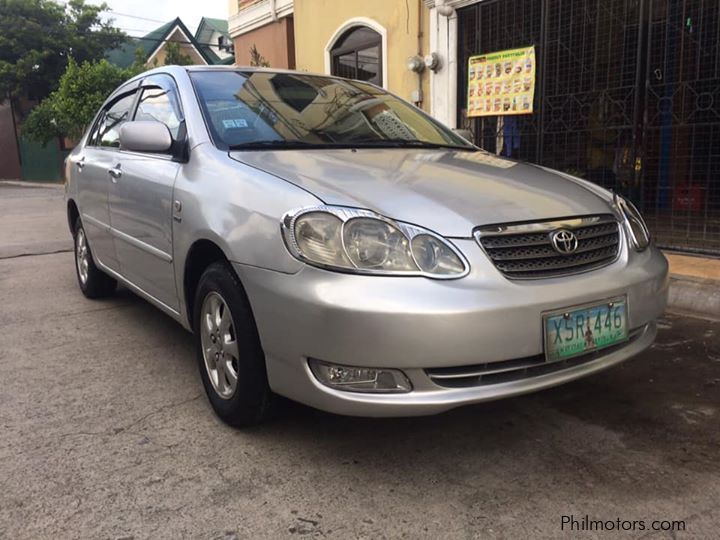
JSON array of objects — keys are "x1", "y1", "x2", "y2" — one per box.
[{"x1": 230, "y1": 0, "x2": 720, "y2": 255}]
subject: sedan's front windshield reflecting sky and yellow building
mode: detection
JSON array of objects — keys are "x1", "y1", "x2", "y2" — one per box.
[{"x1": 190, "y1": 70, "x2": 476, "y2": 151}]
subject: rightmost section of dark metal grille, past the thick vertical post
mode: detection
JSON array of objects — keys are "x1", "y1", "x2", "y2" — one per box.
[{"x1": 640, "y1": 0, "x2": 720, "y2": 254}]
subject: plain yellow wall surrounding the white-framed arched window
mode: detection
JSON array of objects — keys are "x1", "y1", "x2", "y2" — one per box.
[{"x1": 295, "y1": 0, "x2": 430, "y2": 111}]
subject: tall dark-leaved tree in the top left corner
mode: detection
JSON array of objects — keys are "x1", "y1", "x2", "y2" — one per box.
[{"x1": 0, "y1": 0, "x2": 126, "y2": 100}]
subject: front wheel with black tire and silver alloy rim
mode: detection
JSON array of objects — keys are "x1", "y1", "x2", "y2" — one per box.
[{"x1": 193, "y1": 262, "x2": 274, "y2": 427}]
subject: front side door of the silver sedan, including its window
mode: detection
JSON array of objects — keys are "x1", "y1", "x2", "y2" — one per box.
[{"x1": 109, "y1": 75, "x2": 184, "y2": 310}]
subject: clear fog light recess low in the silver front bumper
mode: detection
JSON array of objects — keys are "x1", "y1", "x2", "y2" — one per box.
[{"x1": 308, "y1": 358, "x2": 412, "y2": 394}]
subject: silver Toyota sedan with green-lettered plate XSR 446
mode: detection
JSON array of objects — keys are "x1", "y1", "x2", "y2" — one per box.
[{"x1": 66, "y1": 67, "x2": 668, "y2": 426}]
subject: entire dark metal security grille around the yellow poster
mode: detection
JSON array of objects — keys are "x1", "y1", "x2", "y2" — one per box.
[{"x1": 458, "y1": 0, "x2": 720, "y2": 254}]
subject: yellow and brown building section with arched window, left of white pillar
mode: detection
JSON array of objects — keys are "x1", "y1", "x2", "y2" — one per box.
[{"x1": 229, "y1": 0, "x2": 430, "y2": 111}]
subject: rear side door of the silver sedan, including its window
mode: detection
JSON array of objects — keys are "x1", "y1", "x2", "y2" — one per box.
[{"x1": 71, "y1": 90, "x2": 136, "y2": 271}]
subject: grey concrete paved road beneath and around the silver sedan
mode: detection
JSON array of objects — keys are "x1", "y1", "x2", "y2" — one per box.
[{"x1": 0, "y1": 186, "x2": 720, "y2": 539}]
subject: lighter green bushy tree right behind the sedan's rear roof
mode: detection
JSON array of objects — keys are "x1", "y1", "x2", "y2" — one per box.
[{"x1": 22, "y1": 58, "x2": 145, "y2": 144}]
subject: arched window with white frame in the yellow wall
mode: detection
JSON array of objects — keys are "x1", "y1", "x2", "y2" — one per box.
[{"x1": 332, "y1": 26, "x2": 382, "y2": 84}]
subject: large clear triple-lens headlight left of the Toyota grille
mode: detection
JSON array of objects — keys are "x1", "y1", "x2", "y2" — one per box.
[{"x1": 282, "y1": 206, "x2": 469, "y2": 279}]
